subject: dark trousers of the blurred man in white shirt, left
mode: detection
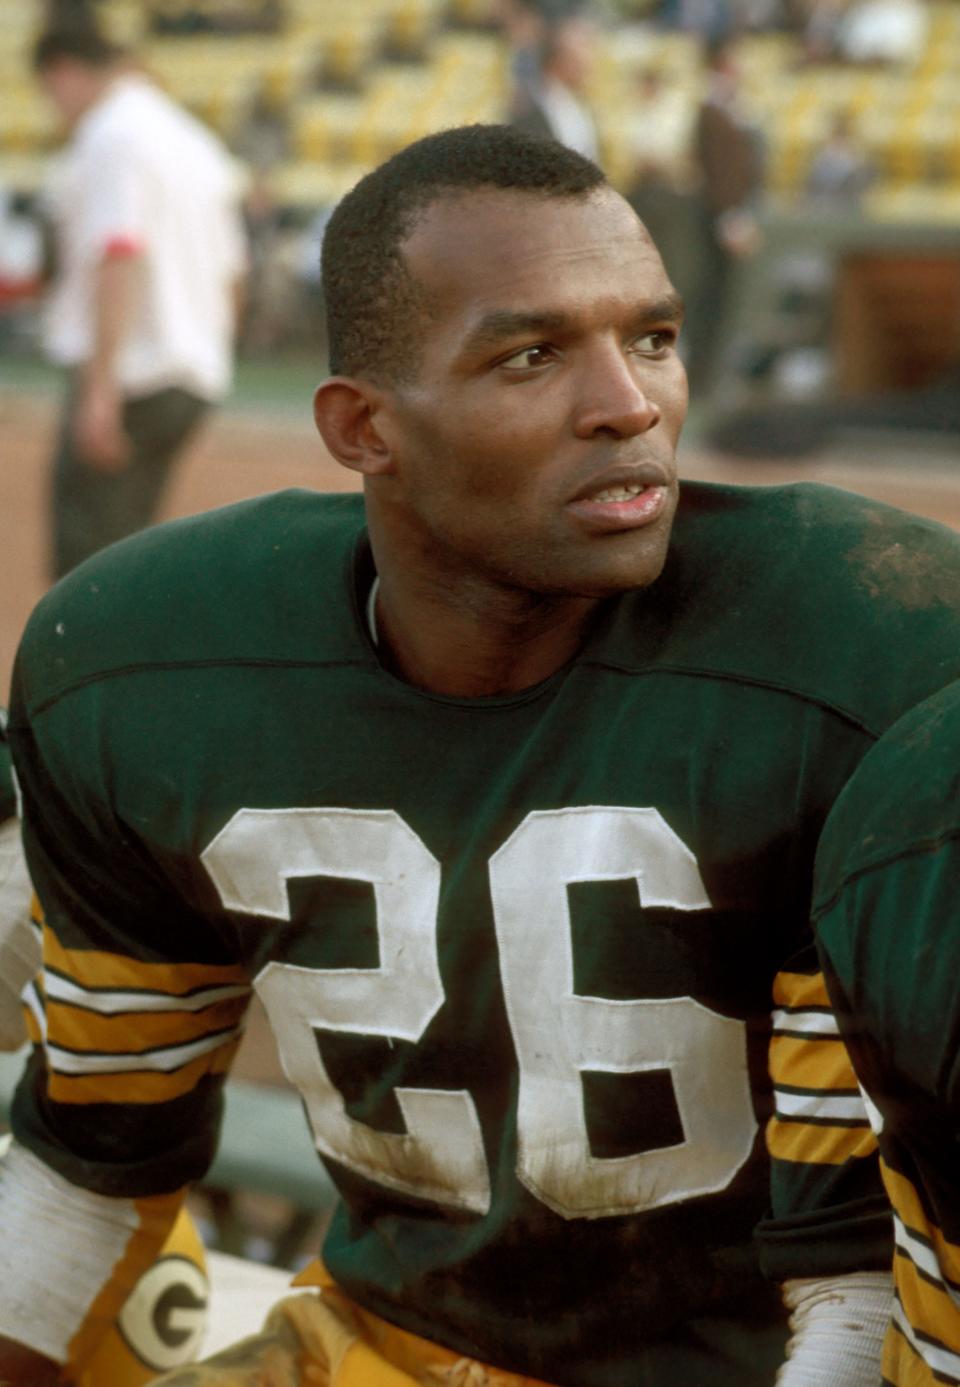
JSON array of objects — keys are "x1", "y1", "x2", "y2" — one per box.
[{"x1": 51, "y1": 388, "x2": 209, "y2": 578}]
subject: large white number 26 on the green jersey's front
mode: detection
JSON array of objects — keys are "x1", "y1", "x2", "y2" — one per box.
[{"x1": 203, "y1": 806, "x2": 756, "y2": 1218}]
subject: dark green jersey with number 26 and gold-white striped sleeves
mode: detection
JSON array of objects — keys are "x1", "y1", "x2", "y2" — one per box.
[{"x1": 11, "y1": 484, "x2": 960, "y2": 1387}]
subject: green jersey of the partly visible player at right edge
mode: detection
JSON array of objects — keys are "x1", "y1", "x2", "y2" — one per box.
[{"x1": 816, "y1": 684, "x2": 960, "y2": 1387}]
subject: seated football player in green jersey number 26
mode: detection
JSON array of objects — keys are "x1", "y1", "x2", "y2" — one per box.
[{"x1": 0, "y1": 126, "x2": 960, "y2": 1387}]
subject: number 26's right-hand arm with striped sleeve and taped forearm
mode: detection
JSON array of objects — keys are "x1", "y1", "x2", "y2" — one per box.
[{"x1": 759, "y1": 947, "x2": 892, "y2": 1387}]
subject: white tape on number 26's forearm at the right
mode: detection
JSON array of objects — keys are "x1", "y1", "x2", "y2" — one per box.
[{"x1": 777, "y1": 1272, "x2": 893, "y2": 1387}]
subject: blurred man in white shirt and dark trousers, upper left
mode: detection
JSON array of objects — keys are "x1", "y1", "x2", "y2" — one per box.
[{"x1": 33, "y1": 18, "x2": 246, "y2": 577}]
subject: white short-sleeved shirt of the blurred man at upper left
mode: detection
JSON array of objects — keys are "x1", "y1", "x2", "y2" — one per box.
[{"x1": 44, "y1": 75, "x2": 246, "y2": 399}]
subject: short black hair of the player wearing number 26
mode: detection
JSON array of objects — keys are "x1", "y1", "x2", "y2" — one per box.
[{"x1": 322, "y1": 125, "x2": 606, "y2": 383}]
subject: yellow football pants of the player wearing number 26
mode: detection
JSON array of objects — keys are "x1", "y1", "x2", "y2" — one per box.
[{"x1": 154, "y1": 1270, "x2": 548, "y2": 1387}]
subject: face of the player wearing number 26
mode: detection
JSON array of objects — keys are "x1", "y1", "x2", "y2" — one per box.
[{"x1": 373, "y1": 189, "x2": 687, "y2": 598}]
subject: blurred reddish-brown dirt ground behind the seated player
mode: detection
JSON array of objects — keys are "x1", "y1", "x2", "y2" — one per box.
[{"x1": 0, "y1": 388, "x2": 960, "y2": 1079}]
